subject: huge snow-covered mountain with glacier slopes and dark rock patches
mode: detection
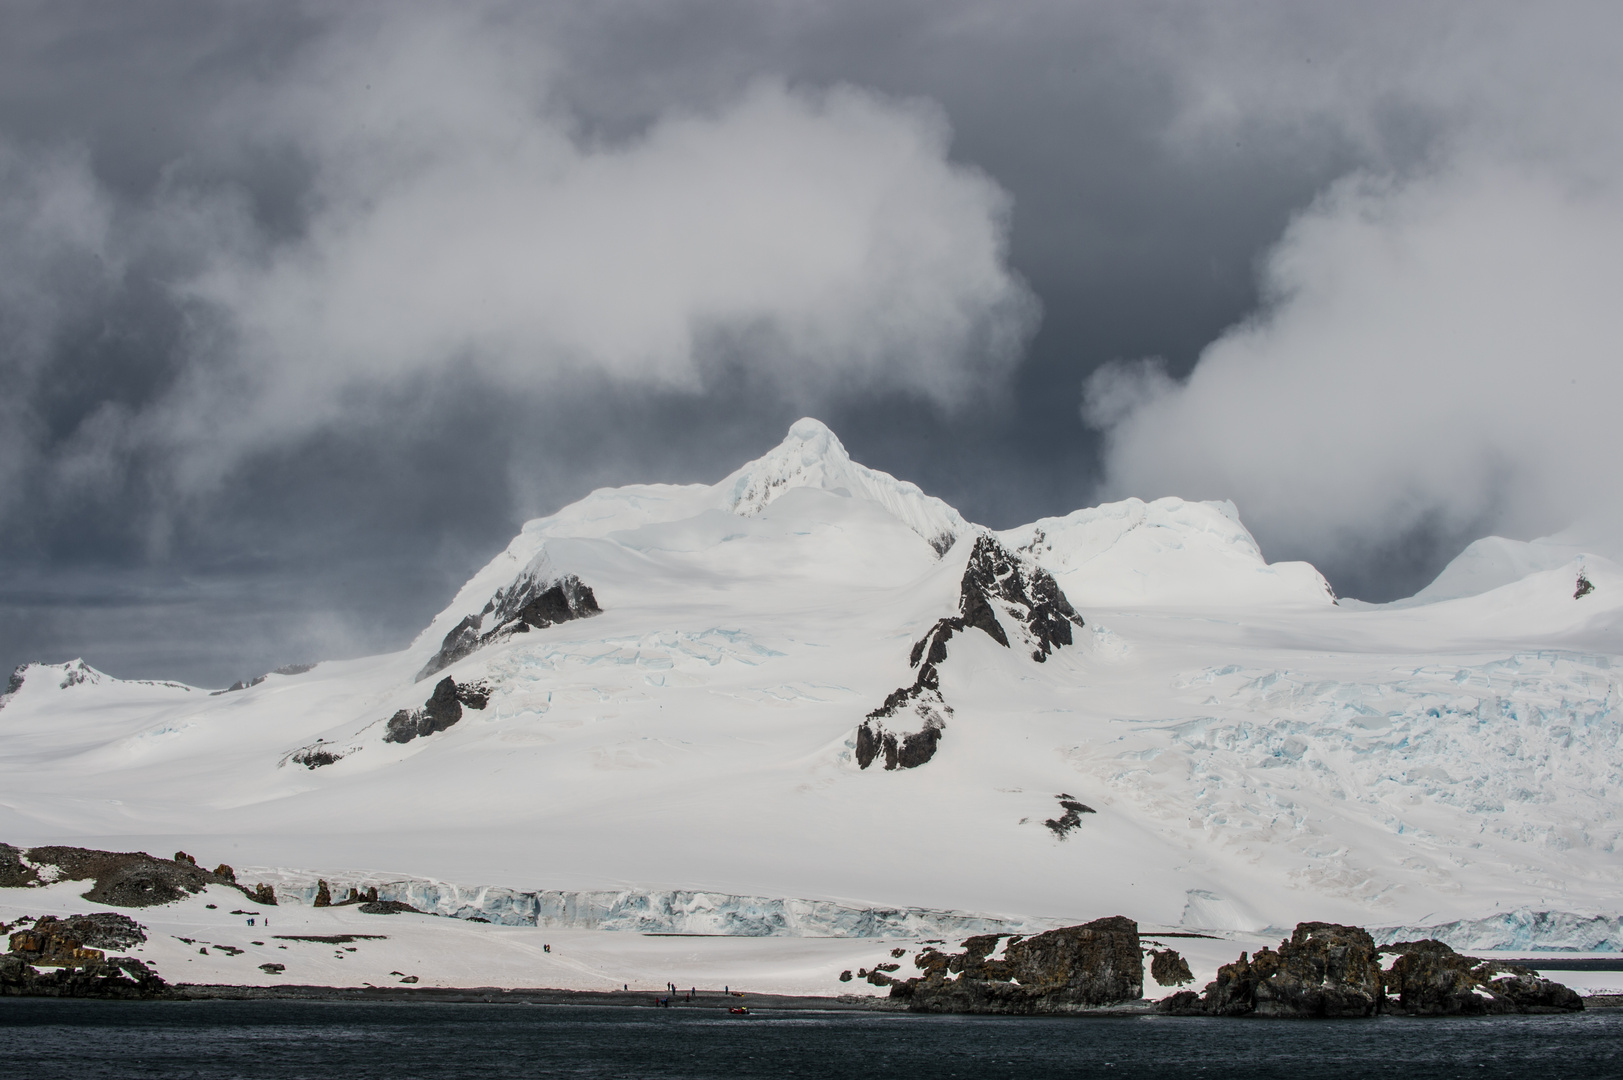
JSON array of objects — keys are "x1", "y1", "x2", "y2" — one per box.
[{"x1": 0, "y1": 421, "x2": 1623, "y2": 947}]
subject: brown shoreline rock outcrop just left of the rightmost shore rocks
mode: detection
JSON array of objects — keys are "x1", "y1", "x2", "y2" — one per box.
[{"x1": 889, "y1": 916, "x2": 1144, "y2": 1013}]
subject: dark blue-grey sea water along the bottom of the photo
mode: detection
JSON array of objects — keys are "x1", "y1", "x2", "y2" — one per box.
[{"x1": 0, "y1": 999, "x2": 1623, "y2": 1080}]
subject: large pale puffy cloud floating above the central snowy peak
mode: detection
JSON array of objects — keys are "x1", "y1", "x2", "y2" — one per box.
[{"x1": 161, "y1": 18, "x2": 1035, "y2": 471}]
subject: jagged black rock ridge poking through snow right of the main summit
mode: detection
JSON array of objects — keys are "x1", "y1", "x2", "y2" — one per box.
[{"x1": 855, "y1": 536, "x2": 1083, "y2": 770}]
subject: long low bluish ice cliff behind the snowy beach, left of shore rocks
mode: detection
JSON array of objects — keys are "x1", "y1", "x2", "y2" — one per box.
[{"x1": 247, "y1": 869, "x2": 1053, "y2": 937}]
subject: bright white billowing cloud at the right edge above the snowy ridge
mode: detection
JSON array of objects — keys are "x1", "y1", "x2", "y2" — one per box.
[{"x1": 1084, "y1": 158, "x2": 1623, "y2": 568}]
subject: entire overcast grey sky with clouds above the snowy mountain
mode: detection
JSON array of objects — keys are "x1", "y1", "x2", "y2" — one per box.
[{"x1": 0, "y1": 0, "x2": 1623, "y2": 684}]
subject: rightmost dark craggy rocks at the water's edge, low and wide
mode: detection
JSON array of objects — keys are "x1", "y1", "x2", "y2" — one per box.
[{"x1": 1160, "y1": 922, "x2": 1584, "y2": 1018}]
